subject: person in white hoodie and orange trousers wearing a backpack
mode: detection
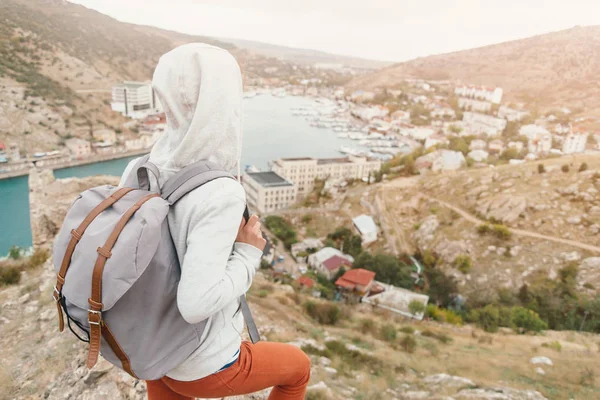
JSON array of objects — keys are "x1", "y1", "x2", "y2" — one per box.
[{"x1": 123, "y1": 44, "x2": 310, "y2": 400}]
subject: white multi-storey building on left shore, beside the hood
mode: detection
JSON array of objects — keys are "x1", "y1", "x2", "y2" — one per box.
[{"x1": 111, "y1": 81, "x2": 161, "y2": 119}]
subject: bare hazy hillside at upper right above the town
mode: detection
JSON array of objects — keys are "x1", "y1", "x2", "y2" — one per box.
[{"x1": 350, "y1": 26, "x2": 600, "y2": 116}]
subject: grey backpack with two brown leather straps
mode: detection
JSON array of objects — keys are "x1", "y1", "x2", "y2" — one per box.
[{"x1": 53, "y1": 156, "x2": 259, "y2": 380}]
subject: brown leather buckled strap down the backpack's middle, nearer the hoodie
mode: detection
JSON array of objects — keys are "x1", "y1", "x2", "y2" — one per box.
[{"x1": 86, "y1": 193, "x2": 160, "y2": 372}]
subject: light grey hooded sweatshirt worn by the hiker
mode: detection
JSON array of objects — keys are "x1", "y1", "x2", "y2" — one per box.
[{"x1": 122, "y1": 43, "x2": 262, "y2": 381}]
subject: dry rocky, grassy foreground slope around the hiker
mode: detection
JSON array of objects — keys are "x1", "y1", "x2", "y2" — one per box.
[{"x1": 0, "y1": 171, "x2": 600, "y2": 400}]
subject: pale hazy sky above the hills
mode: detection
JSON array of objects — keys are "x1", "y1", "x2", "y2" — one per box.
[{"x1": 73, "y1": 0, "x2": 600, "y2": 61}]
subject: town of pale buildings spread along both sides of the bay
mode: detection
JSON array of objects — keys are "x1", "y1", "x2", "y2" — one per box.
[{"x1": 0, "y1": 70, "x2": 600, "y2": 178}]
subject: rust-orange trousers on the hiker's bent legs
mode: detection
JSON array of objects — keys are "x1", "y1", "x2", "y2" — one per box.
[{"x1": 146, "y1": 342, "x2": 310, "y2": 400}]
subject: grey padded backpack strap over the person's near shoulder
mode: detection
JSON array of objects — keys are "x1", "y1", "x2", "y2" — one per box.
[{"x1": 161, "y1": 161, "x2": 235, "y2": 205}]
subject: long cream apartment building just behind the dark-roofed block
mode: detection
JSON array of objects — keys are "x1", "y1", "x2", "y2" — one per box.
[{"x1": 272, "y1": 156, "x2": 381, "y2": 196}]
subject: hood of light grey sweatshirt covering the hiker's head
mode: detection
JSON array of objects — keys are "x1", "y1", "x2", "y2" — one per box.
[{"x1": 150, "y1": 43, "x2": 242, "y2": 175}]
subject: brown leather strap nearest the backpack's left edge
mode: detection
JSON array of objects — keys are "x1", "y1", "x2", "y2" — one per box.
[{"x1": 52, "y1": 188, "x2": 133, "y2": 332}]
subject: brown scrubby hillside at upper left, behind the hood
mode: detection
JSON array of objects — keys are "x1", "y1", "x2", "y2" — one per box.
[{"x1": 0, "y1": 0, "x2": 346, "y2": 153}]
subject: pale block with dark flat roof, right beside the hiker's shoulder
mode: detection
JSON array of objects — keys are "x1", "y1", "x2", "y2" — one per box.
[{"x1": 242, "y1": 171, "x2": 297, "y2": 213}]
